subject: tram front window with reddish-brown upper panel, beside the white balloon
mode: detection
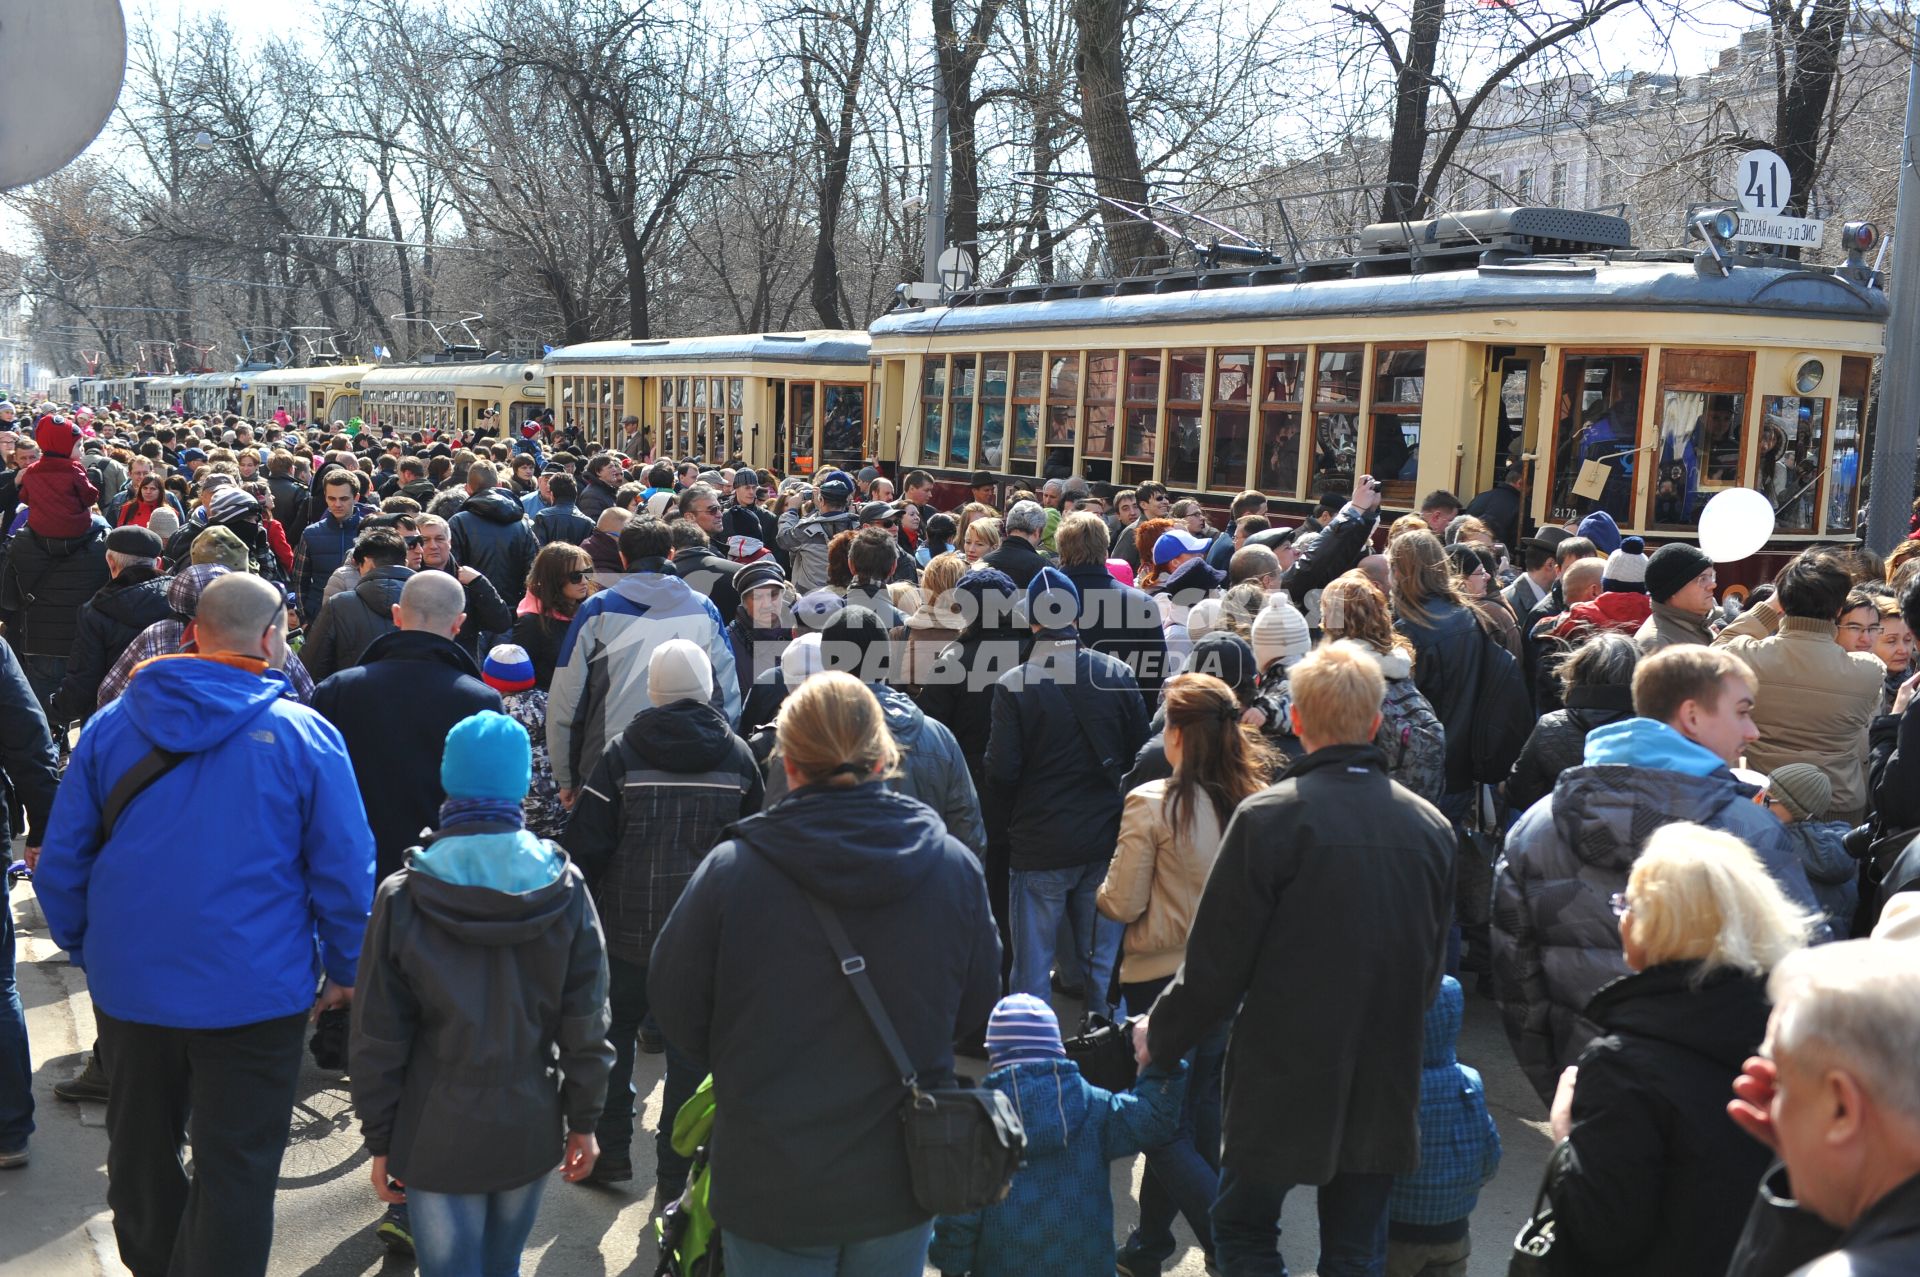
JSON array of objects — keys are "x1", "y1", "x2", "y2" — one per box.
[{"x1": 1651, "y1": 351, "x2": 1753, "y2": 528}]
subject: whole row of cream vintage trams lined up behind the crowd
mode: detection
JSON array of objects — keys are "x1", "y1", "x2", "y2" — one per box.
[{"x1": 37, "y1": 207, "x2": 1887, "y2": 576}]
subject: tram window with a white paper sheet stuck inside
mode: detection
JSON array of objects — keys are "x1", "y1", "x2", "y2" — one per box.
[{"x1": 1549, "y1": 355, "x2": 1645, "y2": 526}]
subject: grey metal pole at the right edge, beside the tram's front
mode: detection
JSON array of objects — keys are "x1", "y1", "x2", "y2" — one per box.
[{"x1": 1862, "y1": 14, "x2": 1920, "y2": 553}]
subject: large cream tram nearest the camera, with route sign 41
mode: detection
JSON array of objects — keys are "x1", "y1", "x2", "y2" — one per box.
[{"x1": 872, "y1": 209, "x2": 1887, "y2": 568}]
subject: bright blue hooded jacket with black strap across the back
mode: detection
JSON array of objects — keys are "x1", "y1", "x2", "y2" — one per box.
[{"x1": 35, "y1": 657, "x2": 374, "y2": 1029}]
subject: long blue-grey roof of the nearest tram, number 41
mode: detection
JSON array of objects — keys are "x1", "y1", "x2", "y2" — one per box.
[{"x1": 872, "y1": 257, "x2": 1887, "y2": 338}]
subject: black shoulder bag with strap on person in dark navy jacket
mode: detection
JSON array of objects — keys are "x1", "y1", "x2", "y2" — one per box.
[{"x1": 770, "y1": 862, "x2": 1027, "y2": 1216}]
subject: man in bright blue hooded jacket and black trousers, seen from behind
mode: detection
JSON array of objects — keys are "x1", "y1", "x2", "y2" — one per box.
[{"x1": 35, "y1": 572, "x2": 372, "y2": 1275}]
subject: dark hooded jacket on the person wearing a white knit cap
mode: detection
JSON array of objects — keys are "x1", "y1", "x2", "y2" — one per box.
[{"x1": 561, "y1": 701, "x2": 766, "y2": 966}]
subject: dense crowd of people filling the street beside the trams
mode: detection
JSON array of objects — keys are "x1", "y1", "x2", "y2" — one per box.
[{"x1": 0, "y1": 391, "x2": 1920, "y2": 1277}]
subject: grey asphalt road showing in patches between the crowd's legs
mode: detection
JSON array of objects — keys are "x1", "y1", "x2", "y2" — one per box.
[{"x1": 0, "y1": 883, "x2": 1549, "y2": 1277}]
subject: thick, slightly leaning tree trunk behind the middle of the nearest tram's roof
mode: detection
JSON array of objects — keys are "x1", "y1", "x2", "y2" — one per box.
[{"x1": 1073, "y1": 0, "x2": 1167, "y2": 275}]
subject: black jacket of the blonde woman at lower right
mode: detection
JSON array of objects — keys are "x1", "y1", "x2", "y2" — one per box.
[{"x1": 1548, "y1": 962, "x2": 1770, "y2": 1277}]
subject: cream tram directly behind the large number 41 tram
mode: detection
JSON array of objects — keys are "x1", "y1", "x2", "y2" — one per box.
[{"x1": 545, "y1": 330, "x2": 877, "y2": 474}]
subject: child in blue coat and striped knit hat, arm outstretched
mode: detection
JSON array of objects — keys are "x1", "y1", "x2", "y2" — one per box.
[{"x1": 927, "y1": 993, "x2": 1187, "y2": 1277}]
